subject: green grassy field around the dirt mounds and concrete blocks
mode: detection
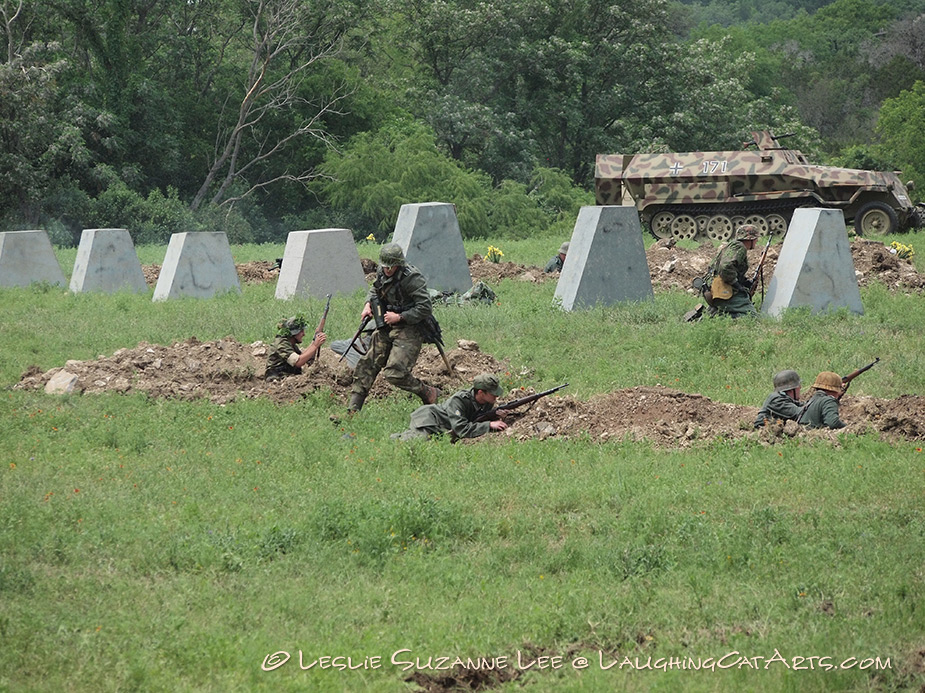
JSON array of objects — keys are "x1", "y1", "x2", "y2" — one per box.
[{"x1": 0, "y1": 237, "x2": 925, "y2": 691}]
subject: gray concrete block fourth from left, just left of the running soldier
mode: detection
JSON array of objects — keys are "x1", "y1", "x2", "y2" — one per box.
[{"x1": 276, "y1": 229, "x2": 367, "y2": 299}]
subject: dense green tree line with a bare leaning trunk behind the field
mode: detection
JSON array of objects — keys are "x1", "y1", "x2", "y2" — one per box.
[{"x1": 0, "y1": 0, "x2": 925, "y2": 245}]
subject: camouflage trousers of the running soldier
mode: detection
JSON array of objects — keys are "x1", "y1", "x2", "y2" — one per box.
[{"x1": 352, "y1": 325, "x2": 427, "y2": 397}]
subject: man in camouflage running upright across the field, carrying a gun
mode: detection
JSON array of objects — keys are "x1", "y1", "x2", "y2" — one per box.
[{"x1": 347, "y1": 243, "x2": 439, "y2": 412}]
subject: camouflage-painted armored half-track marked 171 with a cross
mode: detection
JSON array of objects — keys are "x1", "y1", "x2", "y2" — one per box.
[{"x1": 595, "y1": 130, "x2": 925, "y2": 240}]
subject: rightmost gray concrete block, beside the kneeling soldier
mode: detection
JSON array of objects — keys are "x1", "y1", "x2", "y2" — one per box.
[{"x1": 761, "y1": 208, "x2": 864, "y2": 316}]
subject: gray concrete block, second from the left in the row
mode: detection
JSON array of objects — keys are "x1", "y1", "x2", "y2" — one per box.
[{"x1": 71, "y1": 229, "x2": 148, "y2": 293}]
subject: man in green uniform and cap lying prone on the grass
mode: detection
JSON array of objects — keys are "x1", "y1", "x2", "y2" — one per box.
[{"x1": 392, "y1": 373, "x2": 507, "y2": 440}]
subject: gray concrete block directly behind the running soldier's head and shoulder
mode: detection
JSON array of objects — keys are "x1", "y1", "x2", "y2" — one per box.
[{"x1": 392, "y1": 202, "x2": 472, "y2": 293}]
